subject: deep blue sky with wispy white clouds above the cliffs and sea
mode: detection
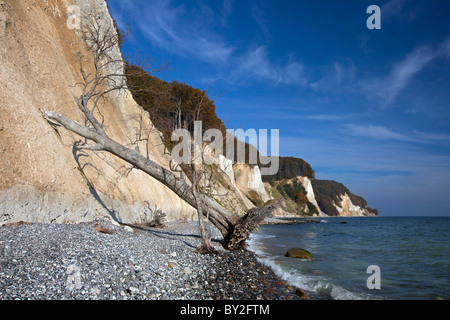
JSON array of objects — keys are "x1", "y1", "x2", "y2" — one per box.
[{"x1": 107, "y1": 0, "x2": 450, "y2": 215}]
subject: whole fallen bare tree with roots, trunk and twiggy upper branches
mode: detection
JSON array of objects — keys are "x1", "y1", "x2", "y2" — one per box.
[{"x1": 41, "y1": 10, "x2": 278, "y2": 250}]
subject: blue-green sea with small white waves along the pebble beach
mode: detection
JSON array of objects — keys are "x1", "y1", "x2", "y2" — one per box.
[{"x1": 249, "y1": 217, "x2": 450, "y2": 300}]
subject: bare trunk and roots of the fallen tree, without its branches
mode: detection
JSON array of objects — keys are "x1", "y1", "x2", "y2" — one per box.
[{"x1": 41, "y1": 110, "x2": 278, "y2": 250}]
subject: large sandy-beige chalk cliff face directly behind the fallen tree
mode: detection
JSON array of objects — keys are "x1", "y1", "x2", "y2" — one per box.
[{"x1": 0, "y1": 0, "x2": 195, "y2": 224}]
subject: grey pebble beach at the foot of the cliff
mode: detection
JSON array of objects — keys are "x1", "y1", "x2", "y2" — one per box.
[{"x1": 0, "y1": 221, "x2": 314, "y2": 300}]
